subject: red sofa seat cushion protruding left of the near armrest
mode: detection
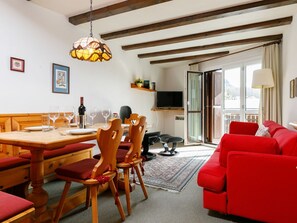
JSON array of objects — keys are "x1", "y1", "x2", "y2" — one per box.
[{"x1": 197, "y1": 152, "x2": 226, "y2": 193}]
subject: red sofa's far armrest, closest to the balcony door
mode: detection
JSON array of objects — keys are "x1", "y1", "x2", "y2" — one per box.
[{"x1": 229, "y1": 121, "x2": 259, "y2": 135}]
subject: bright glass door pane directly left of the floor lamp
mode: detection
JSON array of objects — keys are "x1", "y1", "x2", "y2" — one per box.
[{"x1": 245, "y1": 64, "x2": 261, "y2": 110}]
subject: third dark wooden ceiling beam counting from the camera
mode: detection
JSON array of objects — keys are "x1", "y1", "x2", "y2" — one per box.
[{"x1": 122, "y1": 16, "x2": 293, "y2": 50}]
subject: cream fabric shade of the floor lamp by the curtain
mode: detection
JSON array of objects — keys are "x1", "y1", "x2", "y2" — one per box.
[{"x1": 252, "y1": 69, "x2": 274, "y2": 88}]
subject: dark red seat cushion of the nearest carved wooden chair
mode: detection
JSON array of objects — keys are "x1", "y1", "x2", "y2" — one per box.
[{"x1": 56, "y1": 158, "x2": 98, "y2": 180}]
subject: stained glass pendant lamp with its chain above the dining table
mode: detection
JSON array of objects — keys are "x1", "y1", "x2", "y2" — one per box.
[{"x1": 70, "y1": 0, "x2": 112, "y2": 62}]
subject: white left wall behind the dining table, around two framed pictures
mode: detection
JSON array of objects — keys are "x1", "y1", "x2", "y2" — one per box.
[{"x1": 0, "y1": 0, "x2": 162, "y2": 132}]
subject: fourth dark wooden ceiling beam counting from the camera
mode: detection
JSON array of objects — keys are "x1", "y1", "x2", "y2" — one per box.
[{"x1": 138, "y1": 34, "x2": 283, "y2": 58}]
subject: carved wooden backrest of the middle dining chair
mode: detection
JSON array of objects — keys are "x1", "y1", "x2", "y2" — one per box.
[{"x1": 126, "y1": 116, "x2": 146, "y2": 161}]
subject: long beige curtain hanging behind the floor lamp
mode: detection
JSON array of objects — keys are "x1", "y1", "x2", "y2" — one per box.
[{"x1": 262, "y1": 43, "x2": 282, "y2": 124}]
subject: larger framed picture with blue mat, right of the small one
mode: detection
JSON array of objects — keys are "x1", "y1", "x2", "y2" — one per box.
[{"x1": 52, "y1": 63, "x2": 70, "y2": 94}]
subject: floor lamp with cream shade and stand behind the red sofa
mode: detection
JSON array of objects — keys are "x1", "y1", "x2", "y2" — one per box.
[{"x1": 252, "y1": 68, "x2": 274, "y2": 123}]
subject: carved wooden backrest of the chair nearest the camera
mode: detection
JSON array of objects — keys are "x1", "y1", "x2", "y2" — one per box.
[{"x1": 91, "y1": 119, "x2": 123, "y2": 178}]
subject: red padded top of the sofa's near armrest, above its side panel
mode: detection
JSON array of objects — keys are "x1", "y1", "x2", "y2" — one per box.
[{"x1": 220, "y1": 134, "x2": 280, "y2": 167}]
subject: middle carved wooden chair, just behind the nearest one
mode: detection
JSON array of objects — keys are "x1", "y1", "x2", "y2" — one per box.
[{"x1": 117, "y1": 116, "x2": 148, "y2": 215}]
